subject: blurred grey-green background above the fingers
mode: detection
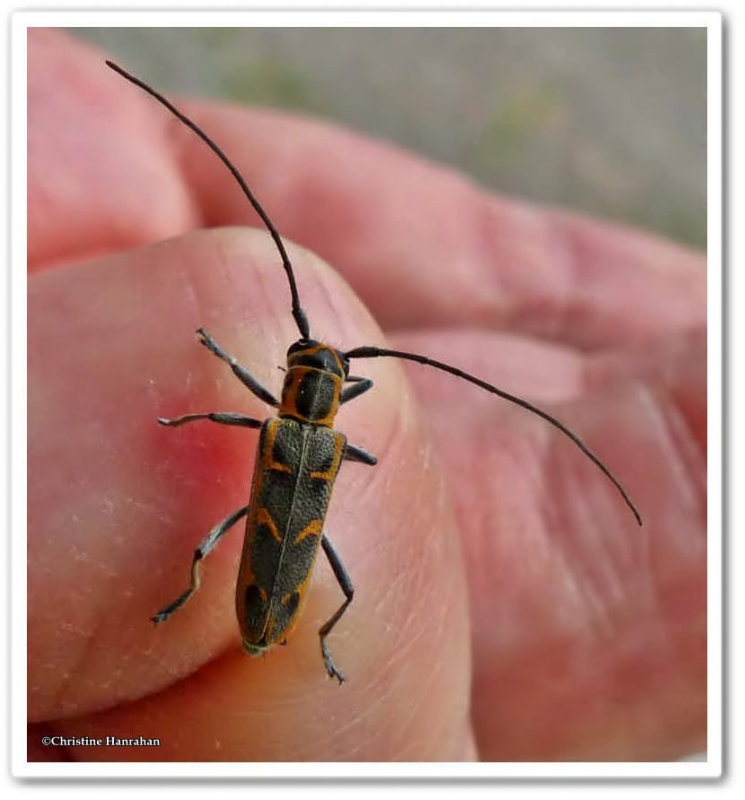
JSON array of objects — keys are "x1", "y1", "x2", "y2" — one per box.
[{"x1": 69, "y1": 28, "x2": 706, "y2": 248}]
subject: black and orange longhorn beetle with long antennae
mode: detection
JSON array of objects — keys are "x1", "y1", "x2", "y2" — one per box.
[{"x1": 106, "y1": 61, "x2": 642, "y2": 683}]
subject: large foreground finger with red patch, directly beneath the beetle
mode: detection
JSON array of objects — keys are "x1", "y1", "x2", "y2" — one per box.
[{"x1": 29, "y1": 230, "x2": 470, "y2": 760}]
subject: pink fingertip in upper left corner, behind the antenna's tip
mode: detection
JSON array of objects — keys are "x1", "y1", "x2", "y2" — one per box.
[{"x1": 28, "y1": 28, "x2": 199, "y2": 271}]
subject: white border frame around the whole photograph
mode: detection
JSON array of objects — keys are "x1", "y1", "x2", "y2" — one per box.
[{"x1": 10, "y1": 10, "x2": 722, "y2": 788}]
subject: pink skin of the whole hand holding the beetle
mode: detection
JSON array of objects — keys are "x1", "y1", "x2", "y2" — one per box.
[{"x1": 28, "y1": 30, "x2": 706, "y2": 761}]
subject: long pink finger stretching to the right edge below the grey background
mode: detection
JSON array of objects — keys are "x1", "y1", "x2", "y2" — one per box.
[{"x1": 184, "y1": 104, "x2": 705, "y2": 348}]
